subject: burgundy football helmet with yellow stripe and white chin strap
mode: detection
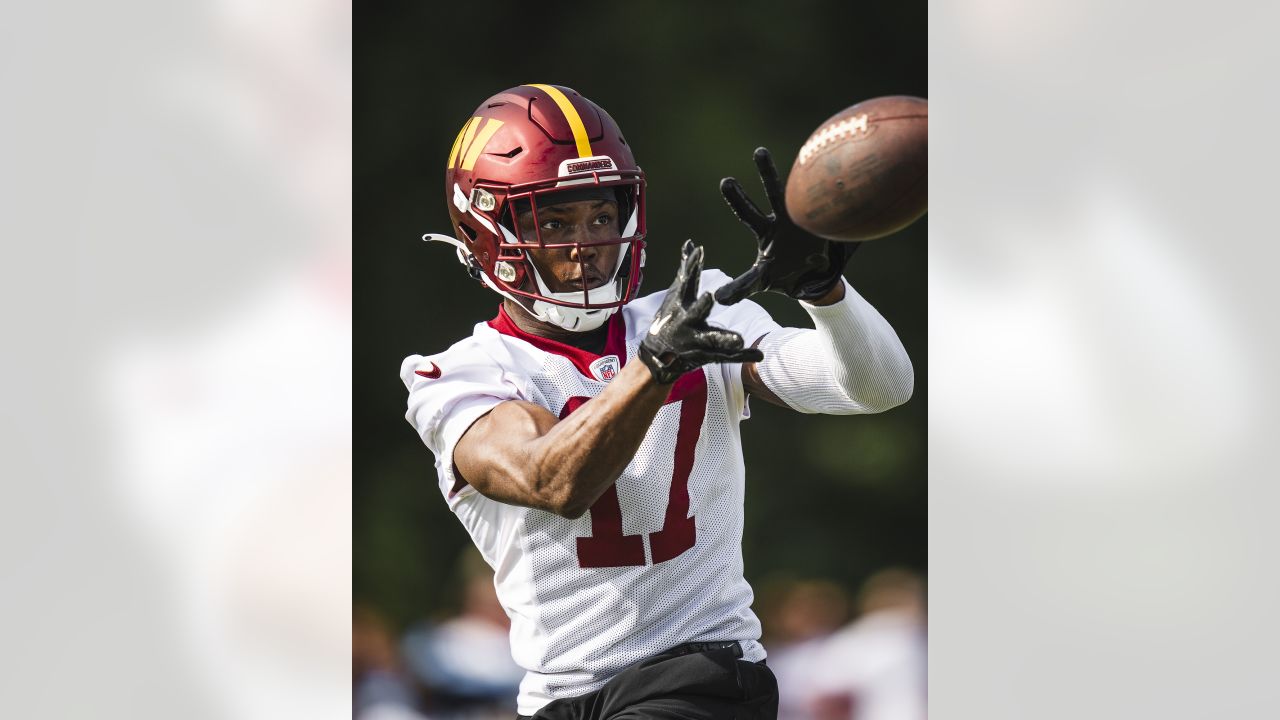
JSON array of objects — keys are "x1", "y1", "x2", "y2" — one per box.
[{"x1": 424, "y1": 85, "x2": 645, "y2": 331}]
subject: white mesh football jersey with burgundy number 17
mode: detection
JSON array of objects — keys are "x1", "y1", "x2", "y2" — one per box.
[{"x1": 401, "y1": 270, "x2": 778, "y2": 715}]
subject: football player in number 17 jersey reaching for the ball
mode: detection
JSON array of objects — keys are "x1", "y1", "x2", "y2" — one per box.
[{"x1": 401, "y1": 85, "x2": 913, "y2": 719}]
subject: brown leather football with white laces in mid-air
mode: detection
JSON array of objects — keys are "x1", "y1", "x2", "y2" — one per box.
[{"x1": 787, "y1": 95, "x2": 929, "y2": 242}]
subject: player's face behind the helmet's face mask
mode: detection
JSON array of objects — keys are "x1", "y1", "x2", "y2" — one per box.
[{"x1": 520, "y1": 200, "x2": 622, "y2": 292}]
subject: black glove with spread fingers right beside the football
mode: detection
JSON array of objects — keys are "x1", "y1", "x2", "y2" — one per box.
[{"x1": 716, "y1": 147, "x2": 861, "y2": 305}]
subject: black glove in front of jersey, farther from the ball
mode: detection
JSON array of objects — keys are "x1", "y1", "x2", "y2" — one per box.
[{"x1": 640, "y1": 240, "x2": 764, "y2": 384}]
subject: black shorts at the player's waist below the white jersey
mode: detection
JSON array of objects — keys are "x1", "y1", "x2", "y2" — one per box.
[{"x1": 520, "y1": 642, "x2": 778, "y2": 720}]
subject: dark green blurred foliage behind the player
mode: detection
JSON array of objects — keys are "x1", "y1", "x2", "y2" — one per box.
[{"x1": 353, "y1": 0, "x2": 928, "y2": 624}]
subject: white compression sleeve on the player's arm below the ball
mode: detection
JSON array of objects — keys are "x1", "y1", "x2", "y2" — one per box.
[{"x1": 755, "y1": 281, "x2": 915, "y2": 415}]
